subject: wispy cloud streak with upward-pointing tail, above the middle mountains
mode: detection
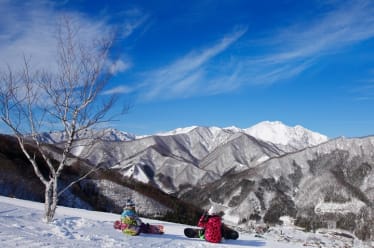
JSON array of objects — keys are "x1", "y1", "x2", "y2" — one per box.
[{"x1": 141, "y1": 28, "x2": 247, "y2": 100}]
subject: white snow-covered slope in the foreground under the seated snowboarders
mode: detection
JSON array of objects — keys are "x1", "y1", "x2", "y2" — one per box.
[{"x1": 0, "y1": 196, "x2": 373, "y2": 248}]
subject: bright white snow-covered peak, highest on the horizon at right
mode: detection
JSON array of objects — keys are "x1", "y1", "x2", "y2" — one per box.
[{"x1": 243, "y1": 121, "x2": 328, "y2": 146}]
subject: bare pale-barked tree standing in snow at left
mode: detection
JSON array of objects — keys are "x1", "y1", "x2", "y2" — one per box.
[{"x1": 0, "y1": 18, "x2": 125, "y2": 222}]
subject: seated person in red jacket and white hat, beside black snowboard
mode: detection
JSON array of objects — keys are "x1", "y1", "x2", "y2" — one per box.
[{"x1": 197, "y1": 206, "x2": 222, "y2": 243}]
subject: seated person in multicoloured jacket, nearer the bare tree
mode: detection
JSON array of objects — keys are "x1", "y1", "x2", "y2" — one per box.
[{"x1": 120, "y1": 199, "x2": 149, "y2": 235}]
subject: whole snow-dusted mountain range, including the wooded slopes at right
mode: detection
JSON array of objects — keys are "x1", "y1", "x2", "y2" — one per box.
[{"x1": 3, "y1": 121, "x2": 374, "y2": 239}]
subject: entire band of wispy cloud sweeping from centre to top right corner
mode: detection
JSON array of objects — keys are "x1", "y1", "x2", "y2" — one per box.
[{"x1": 133, "y1": 0, "x2": 374, "y2": 100}]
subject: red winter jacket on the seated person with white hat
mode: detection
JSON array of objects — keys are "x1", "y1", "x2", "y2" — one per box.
[{"x1": 197, "y1": 215, "x2": 222, "y2": 243}]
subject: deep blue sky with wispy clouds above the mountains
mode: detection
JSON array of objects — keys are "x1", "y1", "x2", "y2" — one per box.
[{"x1": 0, "y1": 0, "x2": 374, "y2": 138}]
